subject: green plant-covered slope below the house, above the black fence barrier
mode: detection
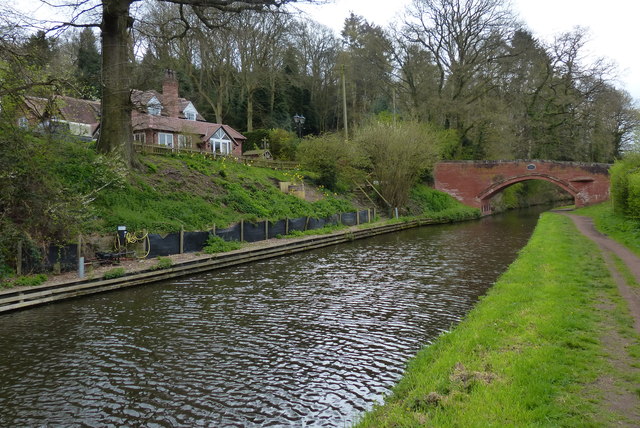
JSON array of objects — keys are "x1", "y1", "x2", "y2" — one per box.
[{"x1": 92, "y1": 155, "x2": 353, "y2": 232}]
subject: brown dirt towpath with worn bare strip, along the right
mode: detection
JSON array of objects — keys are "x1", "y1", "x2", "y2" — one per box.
[{"x1": 559, "y1": 212, "x2": 640, "y2": 427}]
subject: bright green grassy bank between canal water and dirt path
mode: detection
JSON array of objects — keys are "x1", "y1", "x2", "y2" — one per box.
[{"x1": 359, "y1": 214, "x2": 632, "y2": 427}]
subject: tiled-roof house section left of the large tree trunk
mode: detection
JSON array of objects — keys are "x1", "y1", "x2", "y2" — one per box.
[{"x1": 18, "y1": 95, "x2": 100, "y2": 141}]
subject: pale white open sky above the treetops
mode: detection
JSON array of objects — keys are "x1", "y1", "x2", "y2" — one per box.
[{"x1": 298, "y1": 0, "x2": 640, "y2": 102}]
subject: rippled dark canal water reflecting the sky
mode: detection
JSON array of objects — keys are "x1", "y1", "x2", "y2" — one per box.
[{"x1": 0, "y1": 206, "x2": 540, "y2": 427}]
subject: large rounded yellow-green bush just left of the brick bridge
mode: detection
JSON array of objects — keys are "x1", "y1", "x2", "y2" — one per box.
[{"x1": 354, "y1": 122, "x2": 438, "y2": 207}]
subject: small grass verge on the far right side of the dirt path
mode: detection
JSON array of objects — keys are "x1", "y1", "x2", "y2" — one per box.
[{"x1": 575, "y1": 201, "x2": 640, "y2": 256}]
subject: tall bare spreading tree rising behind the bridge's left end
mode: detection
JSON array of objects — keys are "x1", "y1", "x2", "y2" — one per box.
[{"x1": 404, "y1": 0, "x2": 513, "y2": 135}]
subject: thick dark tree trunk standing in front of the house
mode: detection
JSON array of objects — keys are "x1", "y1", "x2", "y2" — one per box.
[{"x1": 96, "y1": 0, "x2": 134, "y2": 166}]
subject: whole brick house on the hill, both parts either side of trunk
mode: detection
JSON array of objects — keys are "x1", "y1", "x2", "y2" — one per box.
[{"x1": 18, "y1": 70, "x2": 246, "y2": 156}]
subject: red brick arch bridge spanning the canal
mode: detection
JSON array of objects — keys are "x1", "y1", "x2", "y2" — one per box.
[{"x1": 434, "y1": 160, "x2": 611, "y2": 215}]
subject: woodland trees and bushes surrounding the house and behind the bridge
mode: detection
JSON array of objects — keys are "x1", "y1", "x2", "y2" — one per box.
[{"x1": 0, "y1": 0, "x2": 640, "y2": 274}]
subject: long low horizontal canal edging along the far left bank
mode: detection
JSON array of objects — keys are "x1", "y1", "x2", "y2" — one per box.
[{"x1": 0, "y1": 219, "x2": 449, "y2": 314}]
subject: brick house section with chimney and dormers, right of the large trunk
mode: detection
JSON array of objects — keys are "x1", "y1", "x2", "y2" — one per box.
[{"x1": 131, "y1": 70, "x2": 246, "y2": 156}]
